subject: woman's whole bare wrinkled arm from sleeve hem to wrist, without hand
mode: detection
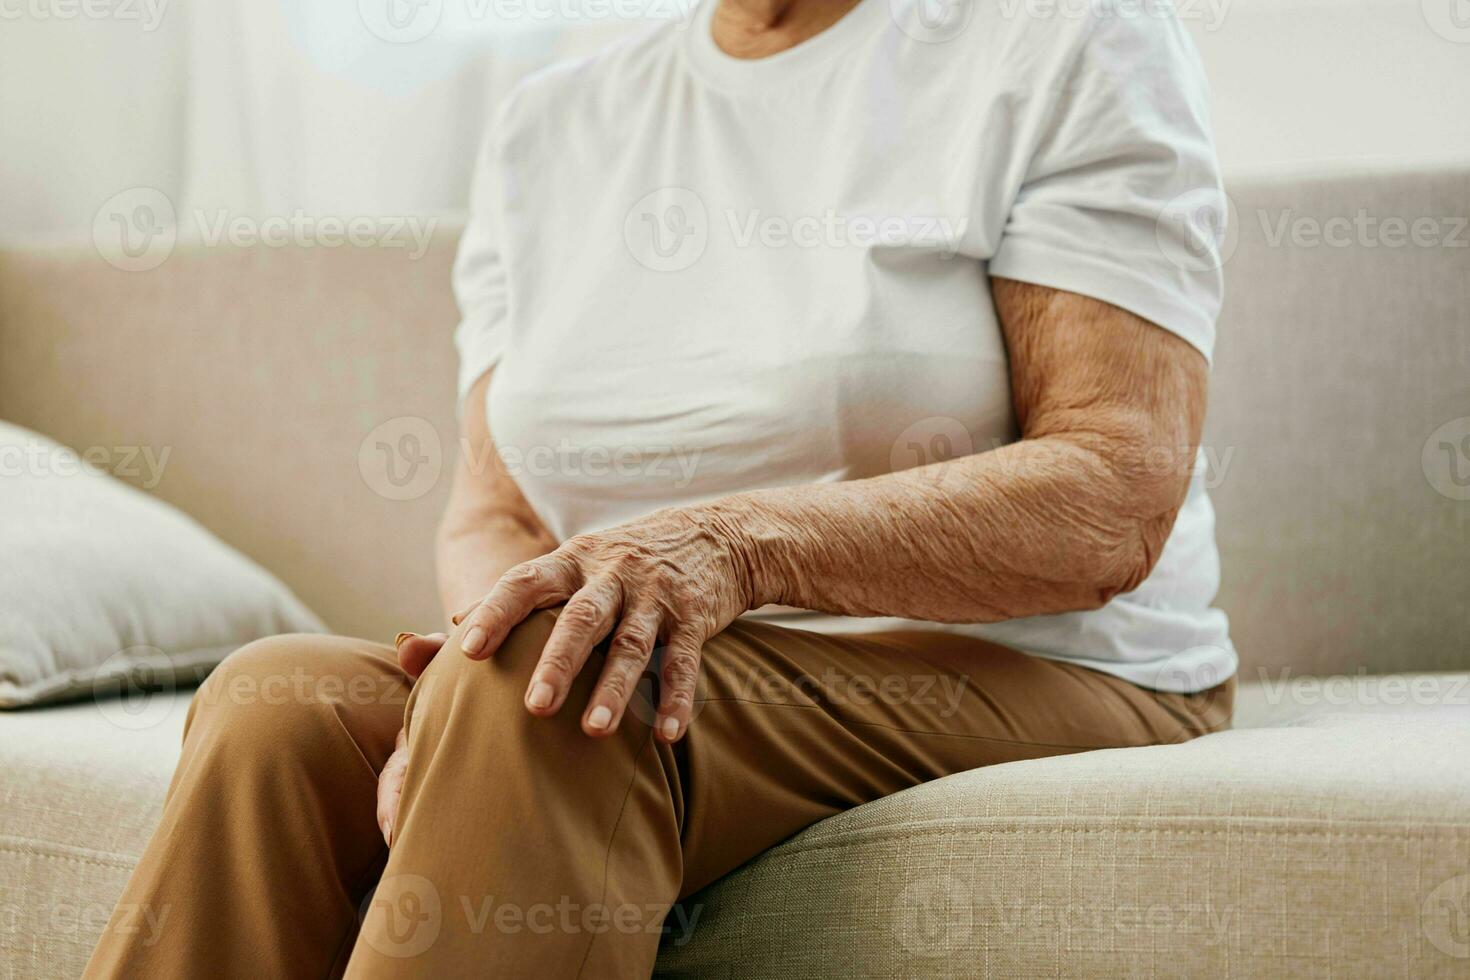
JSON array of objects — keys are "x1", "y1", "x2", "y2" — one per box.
[{"x1": 698, "y1": 278, "x2": 1208, "y2": 623}]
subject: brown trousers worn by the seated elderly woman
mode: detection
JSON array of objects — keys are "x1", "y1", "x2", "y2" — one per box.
[{"x1": 85, "y1": 611, "x2": 1233, "y2": 980}]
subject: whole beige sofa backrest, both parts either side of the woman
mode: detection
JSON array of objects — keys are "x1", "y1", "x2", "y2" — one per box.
[{"x1": 0, "y1": 167, "x2": 1470, "y2": 679}]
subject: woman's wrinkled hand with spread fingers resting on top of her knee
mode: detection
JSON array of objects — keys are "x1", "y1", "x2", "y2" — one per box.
[{"x1": 456, "y1": 508, "x2": 751, "y2": 742}]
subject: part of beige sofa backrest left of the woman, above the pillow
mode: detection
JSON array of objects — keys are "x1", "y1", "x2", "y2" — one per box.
[{"x1": 0, "y1": 226, "x2": 459, "y2": 642}]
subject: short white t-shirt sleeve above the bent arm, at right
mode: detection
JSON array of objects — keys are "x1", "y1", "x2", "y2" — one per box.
[{"x1": 989, "y1": 4, "x2": 1226, "y2": 359}]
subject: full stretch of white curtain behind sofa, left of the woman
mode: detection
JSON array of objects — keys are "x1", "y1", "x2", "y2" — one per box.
[{"x1": 0, "y1": 0, "x2": 645, "y2": 241}]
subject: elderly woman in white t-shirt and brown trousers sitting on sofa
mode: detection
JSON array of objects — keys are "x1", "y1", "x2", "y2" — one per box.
[{"x1": 88, "y1": 0, "x2": 1236, "y2": 977}]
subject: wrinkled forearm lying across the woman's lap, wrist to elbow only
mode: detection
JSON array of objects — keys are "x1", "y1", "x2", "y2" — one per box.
[{"x1": 701, "y1": 433, "x2": 1188, "y2": 623}]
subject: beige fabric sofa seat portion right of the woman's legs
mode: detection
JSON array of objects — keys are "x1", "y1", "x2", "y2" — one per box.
[{"x1": 660, "y1": 693, "x2": 1470, "y2": 977}]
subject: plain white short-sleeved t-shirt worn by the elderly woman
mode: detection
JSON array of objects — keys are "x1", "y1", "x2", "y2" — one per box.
[{"x1": 454, "y1": 0, "x2": 1236, "y2": 691}]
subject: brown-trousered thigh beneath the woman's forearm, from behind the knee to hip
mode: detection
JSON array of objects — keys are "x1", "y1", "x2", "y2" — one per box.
[{"x1": 681, "y1": 621, "x2": 1233, "y2": 895}]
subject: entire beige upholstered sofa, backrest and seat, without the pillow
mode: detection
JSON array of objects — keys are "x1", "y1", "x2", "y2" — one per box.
[{"x1": 0, "y1": 169, "x2": 1470, "y2": 979}]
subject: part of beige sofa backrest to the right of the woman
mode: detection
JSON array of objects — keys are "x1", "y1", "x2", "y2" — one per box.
[{"x1": 1204, "y1": 165, "x2": 1470, "y2": 679}]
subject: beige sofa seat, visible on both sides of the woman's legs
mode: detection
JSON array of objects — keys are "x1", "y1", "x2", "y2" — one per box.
[{"x1": 0, "y1": 676, "x2": 1470, "y2": 977}]
